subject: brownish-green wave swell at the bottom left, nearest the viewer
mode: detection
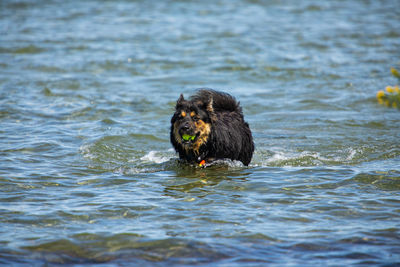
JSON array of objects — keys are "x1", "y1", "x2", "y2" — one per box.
[{"x1": 18, "y1": 237, "x2": 229, "y2": 266}]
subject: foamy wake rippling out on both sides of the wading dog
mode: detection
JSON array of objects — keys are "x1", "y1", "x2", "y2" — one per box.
[{"x1": 79, "y1": 135, "x2": 400, "y2": 173}]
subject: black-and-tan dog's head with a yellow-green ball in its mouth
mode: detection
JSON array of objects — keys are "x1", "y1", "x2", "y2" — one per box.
[{"x1": 171, "y1": 94, "x2": 215, "y2": 153}]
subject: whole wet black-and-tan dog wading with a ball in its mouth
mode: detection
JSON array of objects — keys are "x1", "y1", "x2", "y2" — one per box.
[{"x1": 170, "y1": 89, "x2": 254, "y2": 166}]
